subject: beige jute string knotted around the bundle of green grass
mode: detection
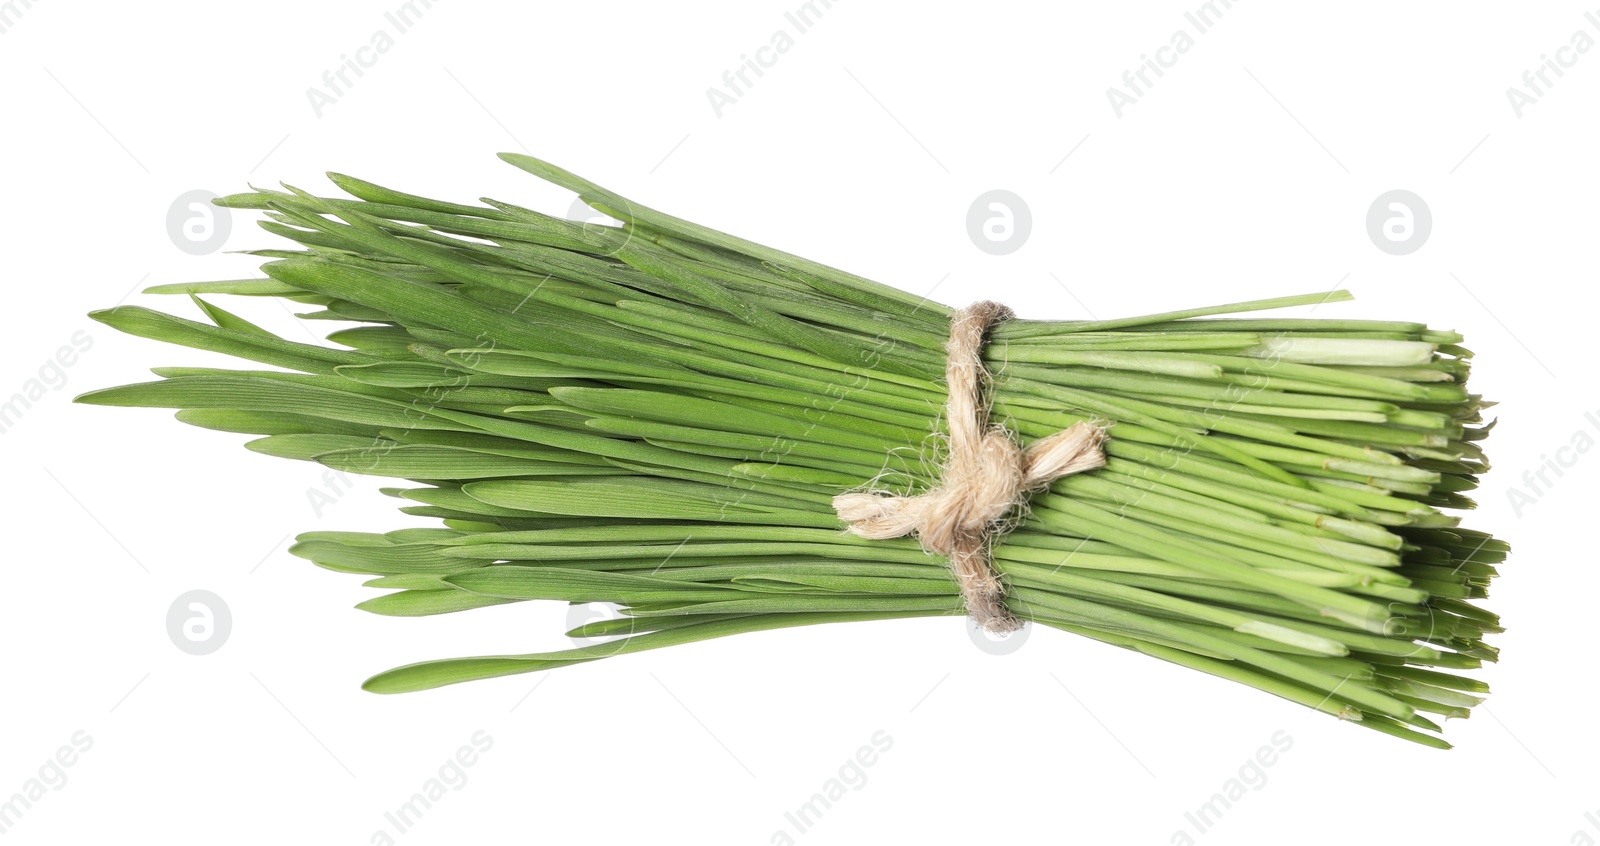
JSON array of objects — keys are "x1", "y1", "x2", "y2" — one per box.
[{"x1": 834, "y1": 301, "x2": 1106, "y2": 633}]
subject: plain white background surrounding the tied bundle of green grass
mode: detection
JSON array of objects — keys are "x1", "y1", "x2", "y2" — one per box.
[{"x1": 0, "y1": 0, "x2": 1600, "y2": 844}]
